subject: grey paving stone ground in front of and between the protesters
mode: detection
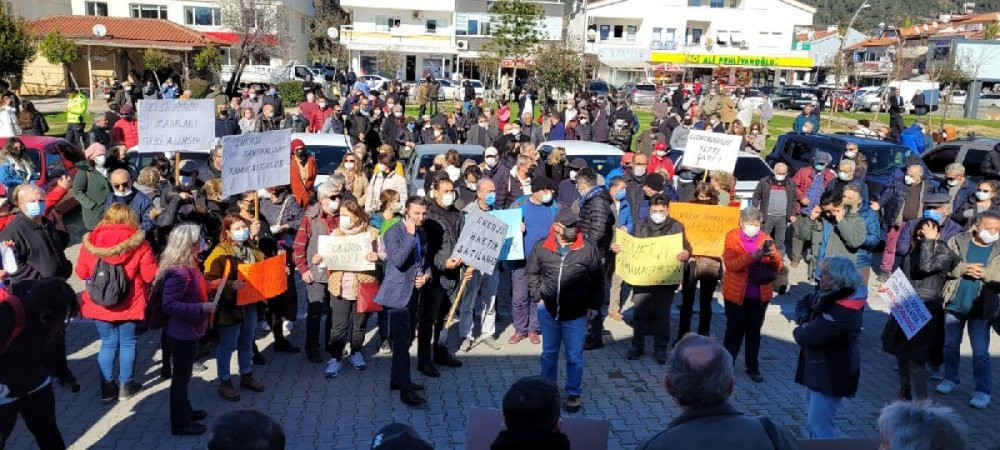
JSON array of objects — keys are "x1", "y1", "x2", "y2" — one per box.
[{"x1": 8, "y1": 247, "x2": 1000, "y2": 449}]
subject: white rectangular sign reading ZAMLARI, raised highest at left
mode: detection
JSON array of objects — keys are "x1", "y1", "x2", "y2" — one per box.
[{"x1": 137, "y1": 99, "x2": 215, "y2": 153}]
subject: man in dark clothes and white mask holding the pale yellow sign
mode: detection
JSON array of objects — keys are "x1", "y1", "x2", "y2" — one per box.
[{"x1": 610, "y1": 194, "x2": 691, "y2": 364}]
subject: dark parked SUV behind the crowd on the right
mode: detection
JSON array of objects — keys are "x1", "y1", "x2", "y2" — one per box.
[{"x1": 767, "y1": 133, "x2": 913, "y2": 197}]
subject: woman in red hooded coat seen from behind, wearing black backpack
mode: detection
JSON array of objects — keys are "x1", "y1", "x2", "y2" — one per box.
[{"x1": 76, "y1": 203, "x2": 156, "y2": 403}]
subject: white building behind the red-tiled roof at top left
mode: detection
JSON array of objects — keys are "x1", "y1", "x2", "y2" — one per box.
[{"x1": 70, "y1": 0, "x2": 315, "y2": 66}]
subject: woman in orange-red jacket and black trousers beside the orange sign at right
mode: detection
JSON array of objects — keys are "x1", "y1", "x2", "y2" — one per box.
[{"x1": 722, "y1": 208, "x2": 781, "y2": 383}]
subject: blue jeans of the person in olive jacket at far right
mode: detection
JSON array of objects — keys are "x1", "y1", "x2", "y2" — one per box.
[{"x1": 944, "y1": 311, "x2": 993, "y2": 394}]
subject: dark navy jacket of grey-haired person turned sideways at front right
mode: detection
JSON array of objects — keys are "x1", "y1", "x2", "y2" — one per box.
[{"x1": 792, "y1": 286, "x2": 868, "y2": 397}]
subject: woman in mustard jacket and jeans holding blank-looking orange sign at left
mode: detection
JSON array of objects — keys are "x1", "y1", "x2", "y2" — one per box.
[{"x1": 205, "y1": 214, "x2": 264, "y2": 402}]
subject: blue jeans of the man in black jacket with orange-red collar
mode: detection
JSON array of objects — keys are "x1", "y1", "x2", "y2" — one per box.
[{"x1": 538, "y1": 303, "x2": 587, "y2": 395}]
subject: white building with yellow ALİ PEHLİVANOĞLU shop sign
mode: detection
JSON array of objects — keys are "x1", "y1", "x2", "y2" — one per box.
[{"x1": 586, "y1": 0, "x2": 816, "y2": 85}]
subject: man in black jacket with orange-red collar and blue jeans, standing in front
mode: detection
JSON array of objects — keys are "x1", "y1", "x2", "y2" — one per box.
[{"x1": 525, "y1": 208, "x2": 604, "y2": 412}]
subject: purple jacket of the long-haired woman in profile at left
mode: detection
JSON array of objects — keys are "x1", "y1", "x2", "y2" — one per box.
[{"x1": 163, "y1": 266, "x2": 209, "y2": 341}]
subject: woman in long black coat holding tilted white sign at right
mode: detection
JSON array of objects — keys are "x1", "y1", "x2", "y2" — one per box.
[{"x1": 882, "y1": 216, "x2": 958, "y2": 401}]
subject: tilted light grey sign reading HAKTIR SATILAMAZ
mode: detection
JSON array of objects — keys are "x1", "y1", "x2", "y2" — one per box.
[{"x1": 458, "y1": 211, "x2": 510, "y2": 275}]
